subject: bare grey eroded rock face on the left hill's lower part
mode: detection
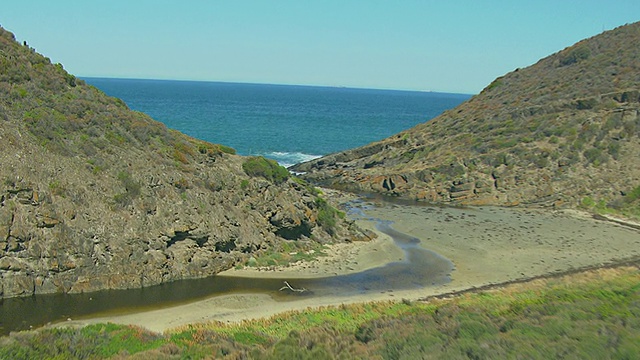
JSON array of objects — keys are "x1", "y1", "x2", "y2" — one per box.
[{"x1": 0, "y1": 155, "x2": 357, "y2": 297}]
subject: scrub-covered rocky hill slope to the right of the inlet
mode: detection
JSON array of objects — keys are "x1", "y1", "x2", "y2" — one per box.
[{"x1": 294, "y1": 23, "x2": 640, "y2": 215}]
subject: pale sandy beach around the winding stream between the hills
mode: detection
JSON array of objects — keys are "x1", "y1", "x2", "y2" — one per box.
[{"x1": 65, "y1": 194, "x2": 640, "y2": 332}]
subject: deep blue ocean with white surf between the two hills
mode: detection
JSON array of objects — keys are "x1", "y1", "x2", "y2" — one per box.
[{"x1": 84, "y1": 78, "x2": 470, "y2": 166}]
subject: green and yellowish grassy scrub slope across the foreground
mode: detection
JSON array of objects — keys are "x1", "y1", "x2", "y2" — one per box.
[{"x1": 0, "y1": 267, "x2": 640, "y2": 359}]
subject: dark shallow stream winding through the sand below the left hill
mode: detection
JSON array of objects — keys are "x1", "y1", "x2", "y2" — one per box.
[{"x1": 0, "y1": 203, "x2": 454, "y2": 334}]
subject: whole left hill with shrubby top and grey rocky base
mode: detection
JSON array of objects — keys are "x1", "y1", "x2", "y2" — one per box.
[{"x1": 0, "y1": 29, "x2": 359, "y2": 297}]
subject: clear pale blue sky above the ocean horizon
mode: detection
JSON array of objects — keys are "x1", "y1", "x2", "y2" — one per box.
[{"x1": 0, "y1": 0, "x2": 640, "y2": 93}]
